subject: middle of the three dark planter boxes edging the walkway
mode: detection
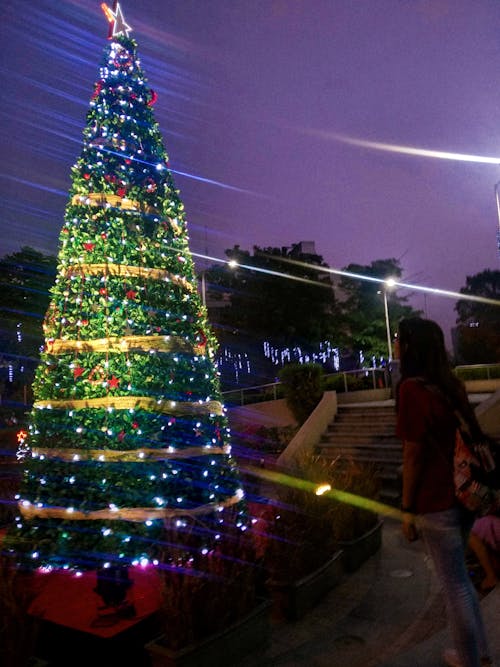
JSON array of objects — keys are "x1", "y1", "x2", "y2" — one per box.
[{"x1": 267, "y1": 550, "x2": 343, "y2": 621}]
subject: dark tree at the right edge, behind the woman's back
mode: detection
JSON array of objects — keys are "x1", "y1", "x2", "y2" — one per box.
[{"x1": 455, "y1": 269, "x2": 500, "y2": 364}]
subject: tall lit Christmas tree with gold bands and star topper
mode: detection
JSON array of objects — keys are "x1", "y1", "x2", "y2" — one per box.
[{"x1": 7, "y1": 3, "x2": 247, "y2": 570}]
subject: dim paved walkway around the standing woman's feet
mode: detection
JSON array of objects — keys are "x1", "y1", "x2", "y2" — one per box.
[{"x1": 237, "y1": 520, "x2": 500, "y2": 667}]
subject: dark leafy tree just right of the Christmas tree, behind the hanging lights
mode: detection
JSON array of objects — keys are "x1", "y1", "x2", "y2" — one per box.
[{"x1": 206, "y1": 244, "x2": 339, "y2": 345}]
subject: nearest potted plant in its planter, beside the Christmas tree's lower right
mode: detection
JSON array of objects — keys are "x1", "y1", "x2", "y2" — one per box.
[{"x1": 146, "y1": 508, "x2": 269, "y2": 667}]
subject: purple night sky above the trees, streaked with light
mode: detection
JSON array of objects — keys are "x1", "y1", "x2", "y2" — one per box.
[{"x1": 0, "y1": 0, "x2": 500, "y2": 344}]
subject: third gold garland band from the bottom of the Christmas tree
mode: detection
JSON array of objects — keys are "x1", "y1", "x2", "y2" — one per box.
[{"x1": 33, "y1": 396, "x2": 223, "y2": 415}]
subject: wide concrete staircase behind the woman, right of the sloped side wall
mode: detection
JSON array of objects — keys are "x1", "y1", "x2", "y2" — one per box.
[{"x1": 317, "y1": 401, "x2": 403, "y2": 505}]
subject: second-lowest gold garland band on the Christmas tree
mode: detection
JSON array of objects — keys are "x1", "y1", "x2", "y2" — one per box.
[{"x1": 31, "y1": 447, "x2": 230, "y2": 463}]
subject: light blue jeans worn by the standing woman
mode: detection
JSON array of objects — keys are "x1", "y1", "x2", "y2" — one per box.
[{"x1": 418, "y1": 507, "x2": 489, "y2": 667}]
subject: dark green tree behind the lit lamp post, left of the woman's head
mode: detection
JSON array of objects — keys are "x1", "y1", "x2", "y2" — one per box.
[{"x1": 339, "y1": 258, "x2": 420, "y2": 359}]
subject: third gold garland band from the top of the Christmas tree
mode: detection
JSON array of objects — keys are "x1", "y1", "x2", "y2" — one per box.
[{"x1": 46, "y1": 336, "x2": 205, "y2": 356}]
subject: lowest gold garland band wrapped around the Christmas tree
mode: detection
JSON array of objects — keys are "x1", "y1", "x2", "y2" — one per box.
[{"x1": 19, "y1": 494, "x2": 241, "y2": 522}]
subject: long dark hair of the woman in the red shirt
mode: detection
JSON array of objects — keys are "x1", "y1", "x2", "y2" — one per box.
[{"x1": 396, "y1": 317, "x2": 479, "y2": 431}]
